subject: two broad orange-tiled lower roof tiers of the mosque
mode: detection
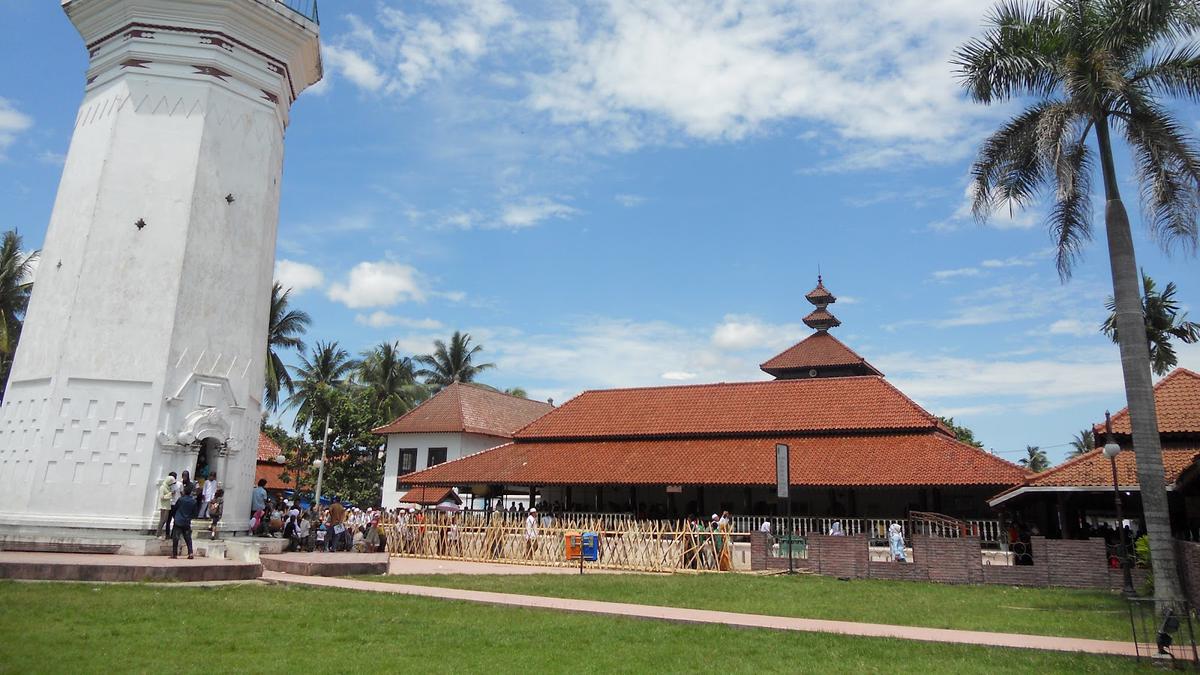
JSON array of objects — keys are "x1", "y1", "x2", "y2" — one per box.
[{"x1": 406, "y1": 376, "x2": 1026, "y2": 486}]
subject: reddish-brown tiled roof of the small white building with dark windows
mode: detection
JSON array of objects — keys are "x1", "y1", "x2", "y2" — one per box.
[{"x1": 374, "y1": 383, "x2": 554, "y2": 438}]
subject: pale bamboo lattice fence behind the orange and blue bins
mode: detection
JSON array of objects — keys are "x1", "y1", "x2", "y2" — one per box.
[{"x1": 380, "y1": 512, "x2": 733, "y2": 572}]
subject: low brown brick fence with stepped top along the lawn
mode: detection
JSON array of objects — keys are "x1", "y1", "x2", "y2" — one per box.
[{"x1": 750, "y1": 532, "x2": 1147, "y2": 588}]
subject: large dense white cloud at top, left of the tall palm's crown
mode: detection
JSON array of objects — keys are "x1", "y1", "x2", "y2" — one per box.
[{"x1": 529, "y1": 0, "x2": 984, "y2": 154}]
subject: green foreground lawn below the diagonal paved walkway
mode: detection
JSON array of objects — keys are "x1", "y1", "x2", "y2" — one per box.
[{"x1": 0, "y1": 581, "x2": 1135, "y2": 674}]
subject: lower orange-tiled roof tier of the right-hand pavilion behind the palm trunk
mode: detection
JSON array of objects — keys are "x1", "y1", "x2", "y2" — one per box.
[{"x1": 991, "y1": 444, "x2": 1200, "y2": 506}]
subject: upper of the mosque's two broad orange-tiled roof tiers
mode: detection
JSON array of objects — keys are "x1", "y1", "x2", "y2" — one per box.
[{"x1": 515, "y1": 376, "x2": 938, "y2": 441}]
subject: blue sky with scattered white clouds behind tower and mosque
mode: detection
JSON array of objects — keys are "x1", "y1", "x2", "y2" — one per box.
[{"x1": 0, "y1": 0, "x2": 1200, "y2": 459}]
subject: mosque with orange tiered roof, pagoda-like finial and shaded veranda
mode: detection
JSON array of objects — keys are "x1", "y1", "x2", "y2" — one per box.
[{"x1": 382, "y1": 277, "x2": 1027, "y2": 519}]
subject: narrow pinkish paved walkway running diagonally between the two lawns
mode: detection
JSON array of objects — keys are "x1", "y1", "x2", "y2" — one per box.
[{"x1": 263, "y1": 566, "x2": 1136, "y2": 656}]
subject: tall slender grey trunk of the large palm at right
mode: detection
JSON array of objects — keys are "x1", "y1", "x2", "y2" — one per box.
[{"x1": 1096, "y1": 118, "x2": 1183, "y2": 602}]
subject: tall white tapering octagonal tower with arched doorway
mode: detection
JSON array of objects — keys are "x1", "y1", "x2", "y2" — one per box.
[{"x1": 0, "y1": 0, "x2": 322, "y2": 530}]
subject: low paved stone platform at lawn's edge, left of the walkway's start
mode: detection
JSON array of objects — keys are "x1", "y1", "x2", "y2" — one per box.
[{"x1": 0, "y1": 551, "x2": 263, "y2": 581}]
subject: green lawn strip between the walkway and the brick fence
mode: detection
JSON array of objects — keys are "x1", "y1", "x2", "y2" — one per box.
[{"x1": 361, "y1": 574, "x2": 1130, "y2": 640}]
